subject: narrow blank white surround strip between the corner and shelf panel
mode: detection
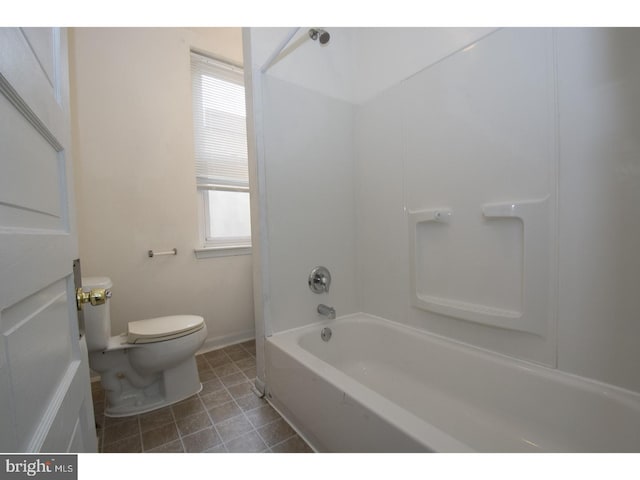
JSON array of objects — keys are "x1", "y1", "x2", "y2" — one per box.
[{"x1": 354, "y1": 85, "x2": 409, "y2": 323}]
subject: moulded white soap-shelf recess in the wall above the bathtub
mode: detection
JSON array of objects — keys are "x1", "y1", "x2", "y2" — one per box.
[{"x1": 408, "y1": 197, "x2": 551, "y2": 336}]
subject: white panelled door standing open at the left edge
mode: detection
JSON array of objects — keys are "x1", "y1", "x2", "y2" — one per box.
[{"x1": 0, "y1": 28, "x2": 96, "y2": 452}]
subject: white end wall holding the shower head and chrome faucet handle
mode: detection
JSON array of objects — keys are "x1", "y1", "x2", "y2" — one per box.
[{"x1": 247, "y1": 28, "x2": 359, "y2": 336}]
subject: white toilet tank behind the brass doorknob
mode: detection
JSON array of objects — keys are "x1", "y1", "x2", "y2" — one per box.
[{"x1": 82, "y1": 277, "x2": 113, "y2": 352}]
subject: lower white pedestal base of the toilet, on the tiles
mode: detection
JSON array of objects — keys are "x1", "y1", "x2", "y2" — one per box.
[{"x1": 103, "y1": 356, "x2": 202, "y2": 417}]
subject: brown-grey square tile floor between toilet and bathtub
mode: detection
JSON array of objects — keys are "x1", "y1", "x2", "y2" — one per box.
[{"x1": 91, "y1": 341, "x2": 312, "y2": 453}]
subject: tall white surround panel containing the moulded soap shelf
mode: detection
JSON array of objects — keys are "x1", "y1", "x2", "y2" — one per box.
[{"x1": 403, "y1": 29, "x2": 558, "y2": 346}]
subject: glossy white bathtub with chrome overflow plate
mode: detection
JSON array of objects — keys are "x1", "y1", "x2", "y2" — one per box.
[{"x1": 265, "y1": 314, "x2": 640, "y2": 452}]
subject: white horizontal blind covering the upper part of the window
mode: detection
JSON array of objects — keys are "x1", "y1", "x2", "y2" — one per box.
[{"x1": 191, "y1": 52, "x2": 249, "y2": 187}]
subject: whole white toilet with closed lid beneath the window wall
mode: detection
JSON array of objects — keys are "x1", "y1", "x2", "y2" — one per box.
[{"x1": 82, "y1": 277, "x2": 207, "y2": 417}]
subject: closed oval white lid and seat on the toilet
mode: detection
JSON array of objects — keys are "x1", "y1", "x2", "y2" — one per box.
[{"x1": 127, "y1": 315, "x2": 204, "y2": 343}]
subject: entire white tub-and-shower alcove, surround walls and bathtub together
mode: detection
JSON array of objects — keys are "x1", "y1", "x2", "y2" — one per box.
[{"x1": 245, "y1": 29, "x2": 640, "y2": 451}]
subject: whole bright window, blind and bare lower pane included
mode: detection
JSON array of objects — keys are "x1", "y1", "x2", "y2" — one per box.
[{"x1": 191, "y1": 52, "x2": 251, "y2": 253}]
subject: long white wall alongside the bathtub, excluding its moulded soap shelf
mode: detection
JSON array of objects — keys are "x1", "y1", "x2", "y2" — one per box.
[{"x1": 356, "y1": 29, "x2": 640, "y2": 391}]
